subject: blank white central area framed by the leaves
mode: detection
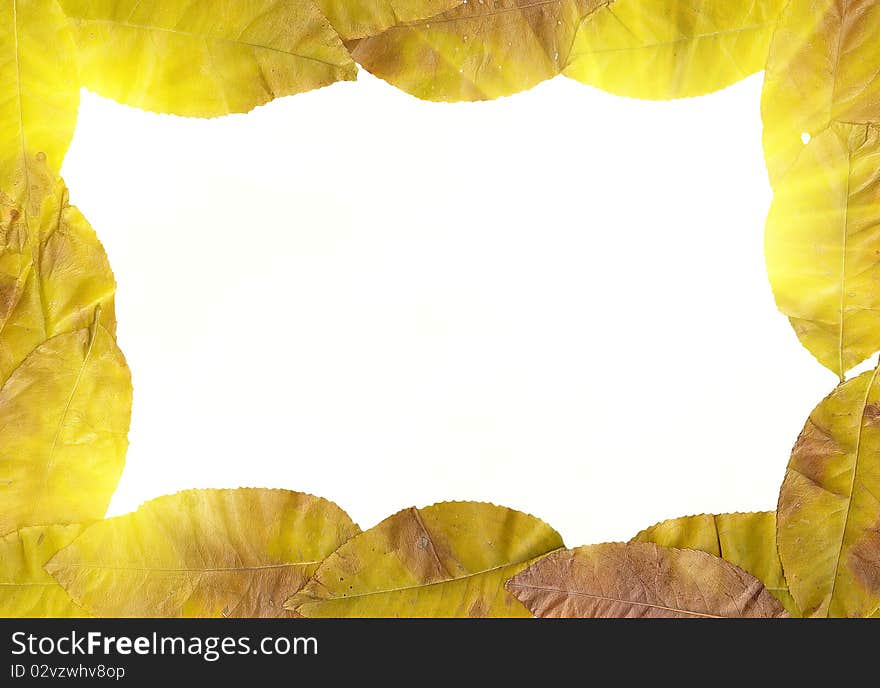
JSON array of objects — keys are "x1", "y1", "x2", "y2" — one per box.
[{"x1": 58, "y1": 74, "x2": 835, "y2": 545}]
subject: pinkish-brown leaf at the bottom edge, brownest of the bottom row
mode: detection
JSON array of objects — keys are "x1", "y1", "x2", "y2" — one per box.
[{"x1": 507, "y1": 542, "x2": 788, "y2": 618}]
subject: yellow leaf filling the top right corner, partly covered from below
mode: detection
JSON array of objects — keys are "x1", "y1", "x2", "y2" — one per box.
[{"x1": 762, "y1": 0, "x2": 880, "y2": 186}]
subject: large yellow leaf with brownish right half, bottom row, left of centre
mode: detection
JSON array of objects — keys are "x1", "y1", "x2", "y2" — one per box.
[{"x1": 46, "y1": 489, "x2": 359, "y2": 617}]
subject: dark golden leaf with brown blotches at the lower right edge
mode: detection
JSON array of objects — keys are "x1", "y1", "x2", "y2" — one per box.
[{"x1": 777, "y1": 370, "x2": 880, "y2": 616}]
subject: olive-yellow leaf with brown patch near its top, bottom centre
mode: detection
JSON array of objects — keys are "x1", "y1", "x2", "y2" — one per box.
[{"x1": 285, "y1": 502, "x2": 563, "y2": 617}]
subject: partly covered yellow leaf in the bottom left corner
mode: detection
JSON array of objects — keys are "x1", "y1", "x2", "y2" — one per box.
[{"x1": 0, "y1": 525, "x2": 88, "y2": 618}]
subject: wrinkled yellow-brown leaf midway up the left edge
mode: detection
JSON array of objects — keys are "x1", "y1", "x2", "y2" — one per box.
[{"x1": 0, "y1": 156, "x2": 116, "y2": 388}]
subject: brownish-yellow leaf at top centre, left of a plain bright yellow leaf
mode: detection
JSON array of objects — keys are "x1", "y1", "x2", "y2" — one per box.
[{"x1": 352, "y1": 0, "x2": 609, "y2": 101}]
